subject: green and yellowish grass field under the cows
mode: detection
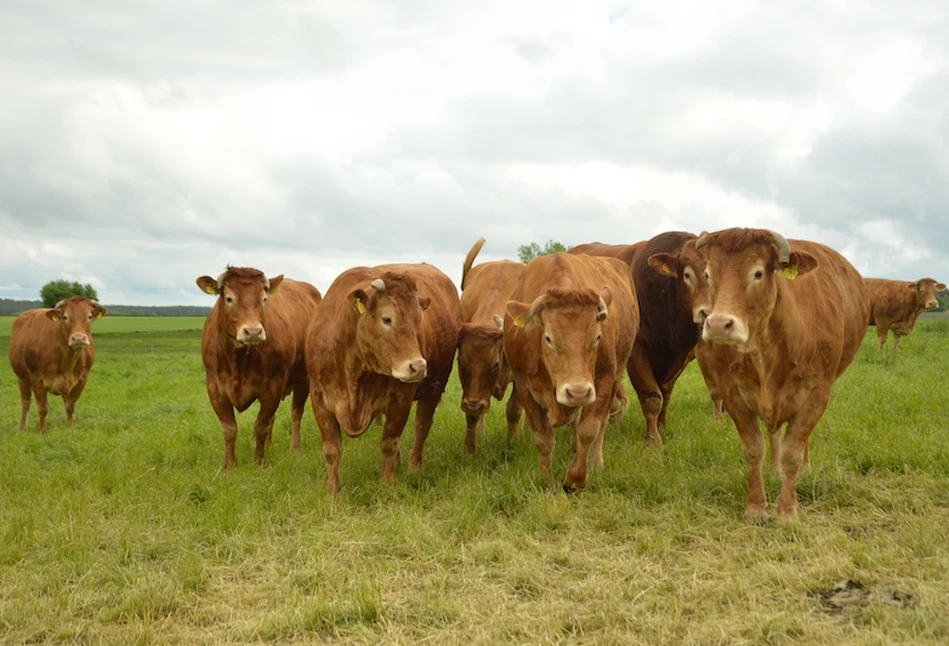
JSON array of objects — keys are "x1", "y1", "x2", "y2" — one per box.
[{"x1": 0, "y1": 317, "x2": 949, "y2": 645}]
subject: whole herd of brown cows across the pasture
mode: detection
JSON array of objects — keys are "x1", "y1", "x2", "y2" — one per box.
[{"x1": 3, "y1": 229, "x2": 946, "y2": 522}]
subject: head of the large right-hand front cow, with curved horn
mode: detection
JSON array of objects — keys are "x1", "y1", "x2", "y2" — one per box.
[{"x1": 695, "y1": 229, "x2": 818, "y2": 347}]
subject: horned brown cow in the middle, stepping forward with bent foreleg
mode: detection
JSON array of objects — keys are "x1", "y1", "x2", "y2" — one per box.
[{"x1": 504, "y1": 252, "x2": 639, "y2": 493}]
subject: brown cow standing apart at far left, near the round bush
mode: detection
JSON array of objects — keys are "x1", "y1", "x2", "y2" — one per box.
[{"x1": 8, "y1": 296, "x2": 107, "y2": 432}]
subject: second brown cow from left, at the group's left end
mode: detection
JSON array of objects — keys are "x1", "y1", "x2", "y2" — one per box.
[{"x1": 197, "y1": 267, "x2": 320, "y2": 469}]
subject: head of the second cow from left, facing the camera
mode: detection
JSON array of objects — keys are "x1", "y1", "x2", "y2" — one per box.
[{"x1": 196, "y1": 267, "x2": 283, "y2": 347}]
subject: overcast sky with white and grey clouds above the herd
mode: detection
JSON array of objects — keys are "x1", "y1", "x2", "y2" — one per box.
[{"x1": 0, "y1": 0, "x2": 949, "y2": 305}]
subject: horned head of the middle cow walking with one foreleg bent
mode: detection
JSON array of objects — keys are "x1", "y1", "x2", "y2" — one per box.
[{"x1": 507, "y1": 286, "x2": 612, "y2": 407}]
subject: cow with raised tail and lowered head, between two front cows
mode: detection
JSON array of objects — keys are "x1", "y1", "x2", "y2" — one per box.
[{"x1": 458, "y1": 238, "x2": 526, "y2": 453}]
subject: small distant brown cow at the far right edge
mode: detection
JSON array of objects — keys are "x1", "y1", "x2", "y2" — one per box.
[{"x1": 863, "y1": 278, "x2": 946, "y2": 350}]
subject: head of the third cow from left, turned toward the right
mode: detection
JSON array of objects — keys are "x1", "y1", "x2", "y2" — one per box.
[{"x1": 348, "y1": 272, "x2": 431, "y2": 383}]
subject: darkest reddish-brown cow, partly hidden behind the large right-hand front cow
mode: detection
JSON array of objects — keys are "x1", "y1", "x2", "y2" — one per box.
[{"x1": 570, "y1": 231, "x2": 707, "y2": 447}]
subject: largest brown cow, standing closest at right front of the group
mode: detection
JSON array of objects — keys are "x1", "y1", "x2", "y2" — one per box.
[{"x1": 696, "y1": 229, "x2": 870, "y2": 523}]
